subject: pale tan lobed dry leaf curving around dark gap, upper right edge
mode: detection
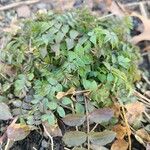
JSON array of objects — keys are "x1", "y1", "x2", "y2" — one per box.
[{"x1": 131, "y1": 12, "x2": 150, "y2": 44}]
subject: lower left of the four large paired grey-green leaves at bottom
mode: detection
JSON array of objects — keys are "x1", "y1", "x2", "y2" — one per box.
[{"x1": 63, "y1": 131, "x2": 87, "y2": 147}]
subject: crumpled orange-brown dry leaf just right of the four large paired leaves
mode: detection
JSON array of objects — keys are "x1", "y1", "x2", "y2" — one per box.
[{"x1": 113, "y1": 124, "x2": 127, "y2": 139}]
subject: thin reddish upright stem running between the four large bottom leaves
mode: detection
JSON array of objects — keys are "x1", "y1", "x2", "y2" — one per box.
[{"x1": 84, "y1": 96, "x2": 90, "y2": 150}]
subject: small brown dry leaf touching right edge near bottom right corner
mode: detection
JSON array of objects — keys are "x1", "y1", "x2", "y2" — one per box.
[{"x1": 136, "y1": 129, "x2": 150, "y2": 142}]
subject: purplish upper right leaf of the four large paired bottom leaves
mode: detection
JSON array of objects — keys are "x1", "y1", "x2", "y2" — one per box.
[{"x1": 88, "y1": 108, "x2": 114, "y2": 123}]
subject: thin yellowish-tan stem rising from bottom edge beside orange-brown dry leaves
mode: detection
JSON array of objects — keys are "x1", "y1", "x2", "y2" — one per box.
[{"x1": 121, "y1": 106, "x2": 132, "y2": 150}]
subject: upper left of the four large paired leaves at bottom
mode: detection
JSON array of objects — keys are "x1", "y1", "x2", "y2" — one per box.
[{"x1": 62, "y1": 114, "x2": 85, "y2": 126}]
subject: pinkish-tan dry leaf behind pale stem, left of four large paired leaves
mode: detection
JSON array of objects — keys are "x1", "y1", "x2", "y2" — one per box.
[{"x1": 43, "y1": 122, "x2": 62, "y2": 137}]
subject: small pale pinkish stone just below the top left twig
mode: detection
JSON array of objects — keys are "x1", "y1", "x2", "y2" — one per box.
[{"x1": 17, "y1": 5, "x2": 31, "y2": 18}]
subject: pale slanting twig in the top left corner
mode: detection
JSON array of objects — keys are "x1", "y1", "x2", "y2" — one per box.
[{"x1": 0, "y1": 0, "x2": 40, "y2": 11}]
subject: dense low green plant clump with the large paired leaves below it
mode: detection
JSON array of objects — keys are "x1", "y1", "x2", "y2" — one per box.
[{"x1": 0, "y1": 9, "x2": 140, "y2": 146}]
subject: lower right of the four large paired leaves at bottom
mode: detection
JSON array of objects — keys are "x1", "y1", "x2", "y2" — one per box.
[{"x1": 89, "y1": 131, "x2": 116, "y2": 146}]
